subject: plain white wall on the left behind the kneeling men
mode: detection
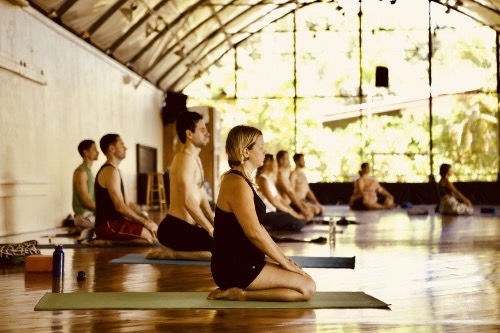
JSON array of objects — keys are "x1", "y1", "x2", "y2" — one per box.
[{"x1": 0, "y1": 1, "x2": 163, "y2": 235}]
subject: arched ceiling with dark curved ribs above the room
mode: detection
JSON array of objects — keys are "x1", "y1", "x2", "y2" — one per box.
[{"x1": 26, "y1": 0, "x2": 500, "y2": 91}]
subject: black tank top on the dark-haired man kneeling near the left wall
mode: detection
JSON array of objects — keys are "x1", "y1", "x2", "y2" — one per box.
[{"x1": 94, "y1": 163, "x2": 125, "y2": 226}]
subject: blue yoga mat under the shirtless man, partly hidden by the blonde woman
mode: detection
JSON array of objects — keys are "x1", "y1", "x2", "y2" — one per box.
[{"x1": 110, "y1": 253, "x2": 356, "y2": 269}]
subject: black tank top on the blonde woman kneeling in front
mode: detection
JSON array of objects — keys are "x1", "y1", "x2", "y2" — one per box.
[{"x1": 212, "y1": 170, "x2": 266, "y2": 264}]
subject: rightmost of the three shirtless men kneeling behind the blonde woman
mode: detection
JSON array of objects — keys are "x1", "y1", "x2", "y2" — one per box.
[{"x1": 290, "y1": 154, "x2": 324, "y2": 216}]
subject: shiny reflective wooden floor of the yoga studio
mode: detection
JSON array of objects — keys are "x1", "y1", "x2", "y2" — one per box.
[{"x1": 0, "y1": 206, "x2": 500, "y2": 333}]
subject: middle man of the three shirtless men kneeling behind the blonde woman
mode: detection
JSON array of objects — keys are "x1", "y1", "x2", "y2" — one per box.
[{"x1": 276, "y1": 150, "x2": 314, "y2": 221}]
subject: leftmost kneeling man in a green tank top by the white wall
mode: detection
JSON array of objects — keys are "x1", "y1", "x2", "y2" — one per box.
[{"x1": 72, "y1": 140, "x2": 99, "y2": 241}]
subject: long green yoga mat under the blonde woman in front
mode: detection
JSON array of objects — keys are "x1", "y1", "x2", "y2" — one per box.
[{"x1": 35, "y1": 292, "x2": 389, "y2": 311}]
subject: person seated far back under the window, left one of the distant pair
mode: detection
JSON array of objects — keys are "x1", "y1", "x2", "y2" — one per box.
[{"x1": 349, "y1": 163, "x2": 394, "y2": 210}]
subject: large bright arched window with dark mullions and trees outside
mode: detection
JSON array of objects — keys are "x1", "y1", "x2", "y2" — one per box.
[{"x1": 184, "y1": 0, "x2": 499, "y2": 182}]
